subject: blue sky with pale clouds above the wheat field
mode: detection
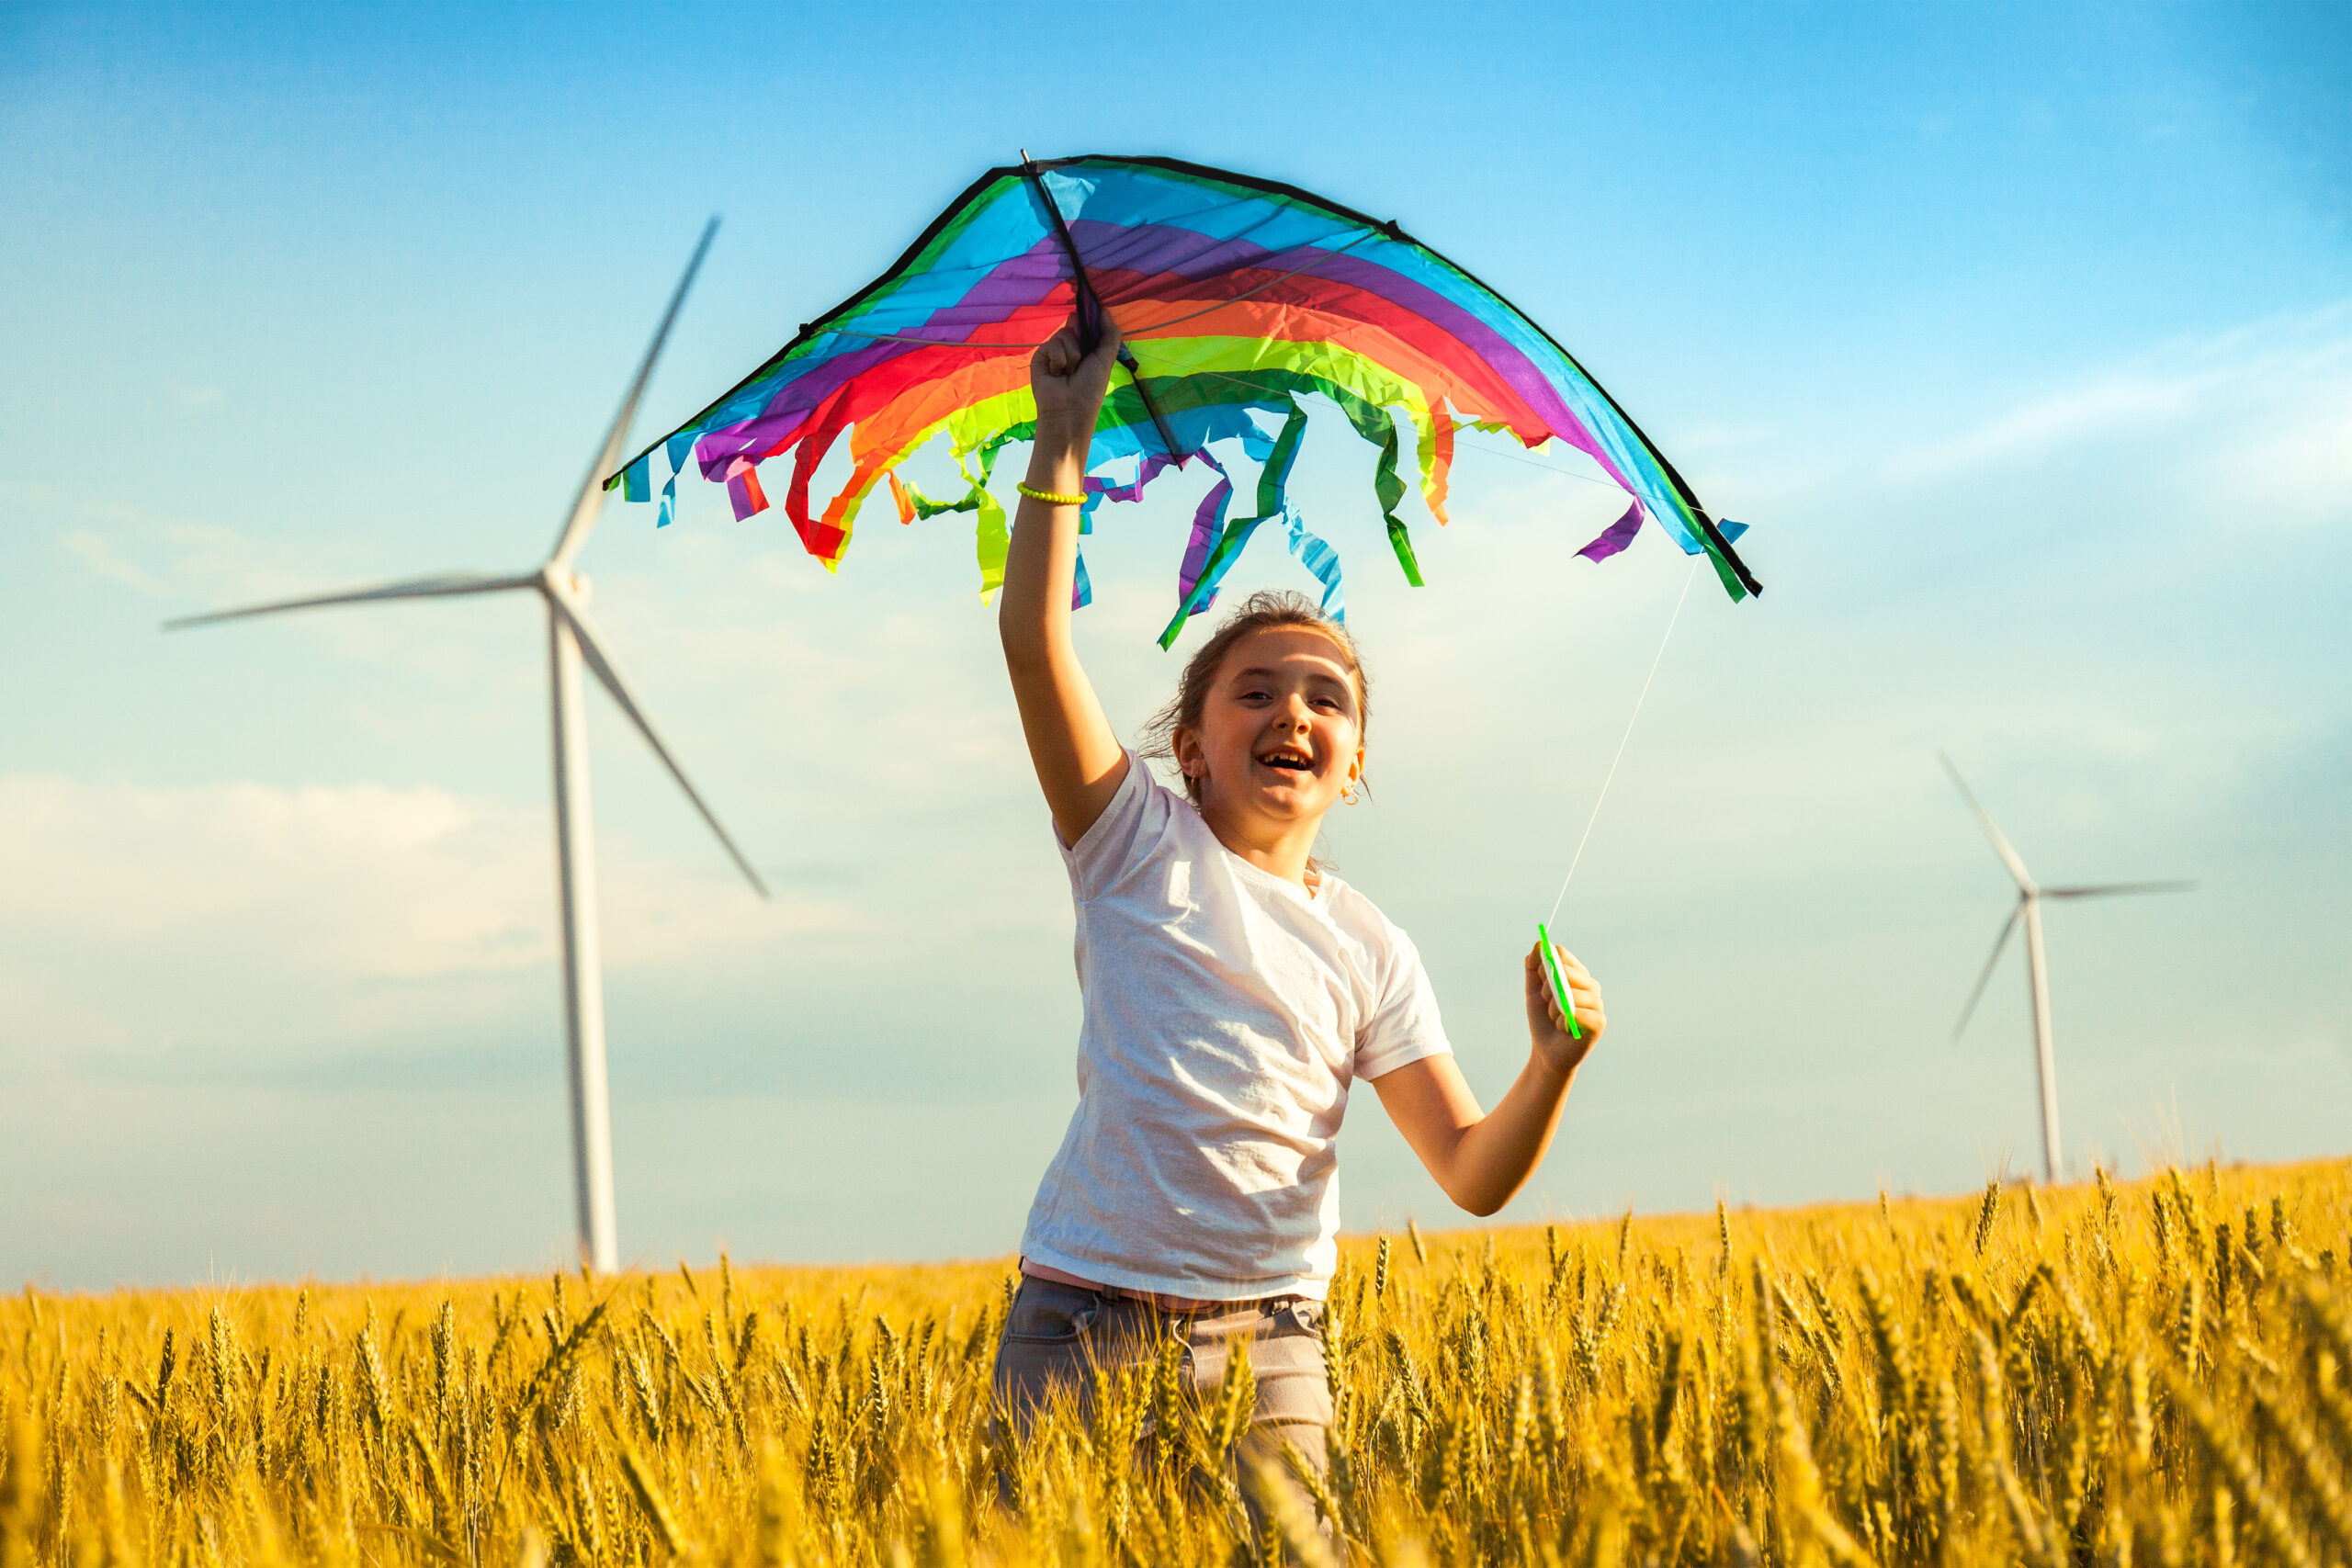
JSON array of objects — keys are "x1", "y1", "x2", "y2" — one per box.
[{"x1": 0, "y1": 5, "x2": 2352, "y2": 1286}]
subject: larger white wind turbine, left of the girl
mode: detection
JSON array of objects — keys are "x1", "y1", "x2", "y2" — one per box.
[{"x1": 164, "y1": 219, "x2": 767, "y2": 1274}]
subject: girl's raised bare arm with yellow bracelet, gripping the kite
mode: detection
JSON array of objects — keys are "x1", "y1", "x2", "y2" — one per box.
[{"x1": 997, "y1": 317, "x2": 1126, "y2": 844}]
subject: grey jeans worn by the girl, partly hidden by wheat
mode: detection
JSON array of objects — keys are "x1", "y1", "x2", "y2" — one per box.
[{"x1": 990, "y1": 1277, "x2": 1331, "y2": 1474}]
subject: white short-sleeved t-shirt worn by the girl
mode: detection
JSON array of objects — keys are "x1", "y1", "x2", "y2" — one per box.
[{"x1": 1021, "y1": 755, "x2": 1452, "y2": 1300}]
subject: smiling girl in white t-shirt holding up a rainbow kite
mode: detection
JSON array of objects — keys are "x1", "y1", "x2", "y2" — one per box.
[{"x1": 995, "y1": 322, "x2": 1606, "y2": 1467}]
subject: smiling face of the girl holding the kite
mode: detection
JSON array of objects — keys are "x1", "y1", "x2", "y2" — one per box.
[{"x1": 1173, "y1": 626, "x2": 1364, "y2": 832}]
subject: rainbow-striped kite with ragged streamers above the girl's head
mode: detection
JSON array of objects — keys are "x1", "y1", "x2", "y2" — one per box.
[{"x1": 605, "y1": 157, "x2": 1761, "y2": 647}]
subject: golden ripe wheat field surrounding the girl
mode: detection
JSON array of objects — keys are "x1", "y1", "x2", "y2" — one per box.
[{"x1": 0, "y1": 1161, "x2": 2352, "y2": 1568}]
